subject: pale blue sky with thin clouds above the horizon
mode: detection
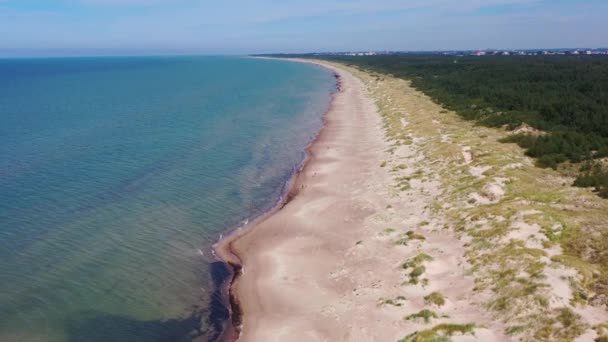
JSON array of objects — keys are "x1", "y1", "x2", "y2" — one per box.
[{"x1": 0, "y1": 0, "x2": 608, "y2": 55}]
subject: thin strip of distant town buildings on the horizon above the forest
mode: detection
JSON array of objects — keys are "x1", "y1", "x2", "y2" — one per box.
[{"x1": 274, "y1": 48, "x2": 608, "y2": 56}]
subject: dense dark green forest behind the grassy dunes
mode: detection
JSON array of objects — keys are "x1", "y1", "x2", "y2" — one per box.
[{"x1": 327, "y1": 55, "x2": 608, "y2": 198}]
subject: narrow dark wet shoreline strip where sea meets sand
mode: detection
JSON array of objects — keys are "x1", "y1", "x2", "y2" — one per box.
[{"x1": 213, "y1": 57, "x2": 342, "y2": 342}]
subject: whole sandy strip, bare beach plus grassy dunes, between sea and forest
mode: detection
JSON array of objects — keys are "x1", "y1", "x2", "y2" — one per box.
[{"x1": 218, "y1": 61, "x2": 608, "y2": 342}]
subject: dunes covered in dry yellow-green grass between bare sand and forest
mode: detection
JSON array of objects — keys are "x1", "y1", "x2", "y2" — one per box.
[{"x1": 332, "y1": 62, "x2": 608, "y2": 341}]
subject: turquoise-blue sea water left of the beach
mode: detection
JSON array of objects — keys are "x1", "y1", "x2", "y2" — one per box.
[{"x1": 0, "y1": 57, "x2": 335, "y2": 341}]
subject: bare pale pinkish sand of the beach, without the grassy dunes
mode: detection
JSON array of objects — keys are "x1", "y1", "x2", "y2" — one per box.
[{"x1": 220, "y1": 62, "x2": 502, "y2": 341}]
